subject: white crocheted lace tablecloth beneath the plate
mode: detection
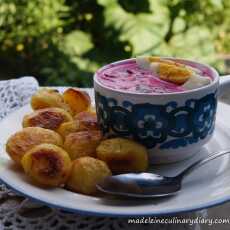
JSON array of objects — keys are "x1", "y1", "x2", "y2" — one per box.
[{"x1": 0, "y1": 77, "x2": 228, "y2": 230}]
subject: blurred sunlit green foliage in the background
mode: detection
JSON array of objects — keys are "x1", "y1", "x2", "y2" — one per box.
[{"x1": 0, "y1": 0, "x2": 230, "y2": 87}]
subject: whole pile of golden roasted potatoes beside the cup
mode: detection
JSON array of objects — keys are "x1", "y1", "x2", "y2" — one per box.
[{"x1": 6, "y1": 88, "x2": 148, "y2": 194}]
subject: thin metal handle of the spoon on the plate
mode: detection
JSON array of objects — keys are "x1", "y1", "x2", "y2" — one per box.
[{"x1": 176, "y1": 149, "x2": 230, "y2": 179}]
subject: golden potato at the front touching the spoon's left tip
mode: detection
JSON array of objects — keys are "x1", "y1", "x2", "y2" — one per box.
[{"x1": 66, "y1": 157, "x2": 112, "y2": 195}]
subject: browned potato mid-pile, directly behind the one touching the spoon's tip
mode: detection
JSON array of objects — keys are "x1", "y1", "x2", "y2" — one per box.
[{"x1": 64, "y1": 130, "x2": 101, "y2": 160}]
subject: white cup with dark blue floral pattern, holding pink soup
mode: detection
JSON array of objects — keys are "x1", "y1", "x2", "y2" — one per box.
[{"x1": 94, "y1": 58, "x2": 230, "y2": 164}]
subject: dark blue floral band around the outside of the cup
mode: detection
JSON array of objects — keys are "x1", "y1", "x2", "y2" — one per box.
[{"x1": 95, "y1": 92, "x2": 217, "y2": 149}]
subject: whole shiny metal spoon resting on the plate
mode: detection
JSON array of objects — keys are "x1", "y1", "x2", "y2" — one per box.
[{"x1": 96, "y1": 150, "x2": 230, "y2": 198}]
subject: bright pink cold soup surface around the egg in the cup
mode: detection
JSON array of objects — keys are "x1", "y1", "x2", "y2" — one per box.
[{"x1": 97, "y1": 60, "x2": 212, "y2": 94}]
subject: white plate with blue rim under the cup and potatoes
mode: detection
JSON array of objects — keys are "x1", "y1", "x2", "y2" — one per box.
[{"x1": 0, "y1": 99, "x2": 230, "y2": 217}]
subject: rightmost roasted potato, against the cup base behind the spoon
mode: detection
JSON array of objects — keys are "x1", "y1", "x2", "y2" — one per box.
[{"x1": 96, "y1": 138, "x2": 148, "y2": 173}]
